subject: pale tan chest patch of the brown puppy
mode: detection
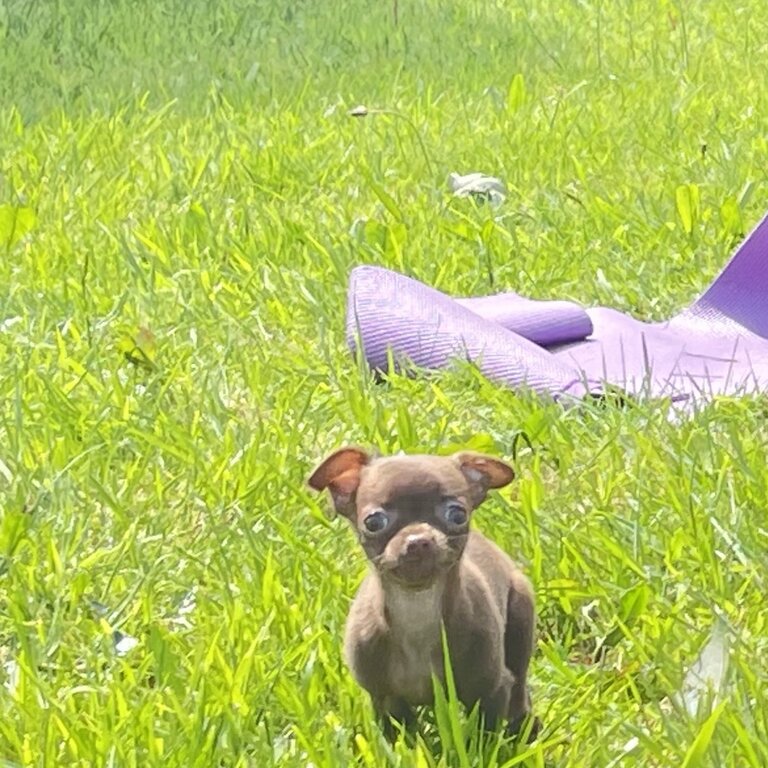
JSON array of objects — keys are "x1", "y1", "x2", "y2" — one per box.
[{"x1": 387, "y1": 590, "x2": 443, "y2": 704}]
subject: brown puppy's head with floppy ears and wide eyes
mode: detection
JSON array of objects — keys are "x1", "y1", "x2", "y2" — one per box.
[{"x1": 309, "y1": 448, "x2": 514, "y2": 588}]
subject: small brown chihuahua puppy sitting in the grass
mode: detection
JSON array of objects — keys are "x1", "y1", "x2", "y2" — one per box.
[{"x1": 309, "y1": 448, "x2": 539, "y2": 739}]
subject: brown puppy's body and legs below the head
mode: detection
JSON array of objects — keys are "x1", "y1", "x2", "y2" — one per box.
[{"x1": 344, "y1": 531, "x2": 533, "y2": 727}]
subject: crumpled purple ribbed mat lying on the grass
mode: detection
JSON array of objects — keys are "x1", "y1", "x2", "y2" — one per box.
[{"x1": 347, "y1": 210, "x2": 768, "y2": 401}]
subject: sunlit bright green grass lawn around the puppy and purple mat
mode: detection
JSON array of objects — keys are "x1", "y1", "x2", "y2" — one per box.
[{"x1": 0, "y1": 0, "x2": 768, "y2": 768}]
